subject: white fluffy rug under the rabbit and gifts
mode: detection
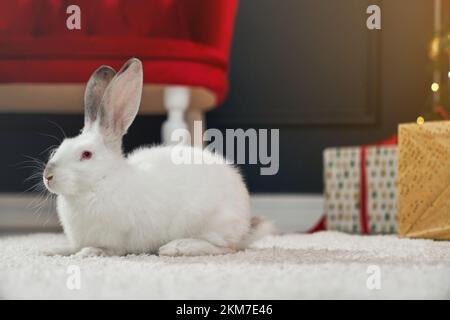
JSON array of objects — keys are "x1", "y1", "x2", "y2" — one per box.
[{"x1": 0, "y1": 232, "x2": 450, "y2": 299}]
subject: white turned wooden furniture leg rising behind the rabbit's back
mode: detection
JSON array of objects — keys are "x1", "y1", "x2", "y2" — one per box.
[{"x1": 161, "y1": 86, "x2": 190, "y2": 144}]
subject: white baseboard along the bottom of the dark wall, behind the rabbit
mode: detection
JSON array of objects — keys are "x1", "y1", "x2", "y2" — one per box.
[{"x1": 0, "y1": 194, "x2": 323, "y2": 232}]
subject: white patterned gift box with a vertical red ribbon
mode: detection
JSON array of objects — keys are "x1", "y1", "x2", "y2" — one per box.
[{"x1": 324, "y1": 138, "x2": 397, "y2": 234}]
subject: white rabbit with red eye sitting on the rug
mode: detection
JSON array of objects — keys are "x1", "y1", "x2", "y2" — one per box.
[{"x1": 43, "y1": 58, "x2": 271, "y2": 257}]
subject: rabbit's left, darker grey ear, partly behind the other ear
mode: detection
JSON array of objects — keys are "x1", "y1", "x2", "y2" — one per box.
[{"x1": 84, "y1": 66, "x2": 116, "y2": 127}]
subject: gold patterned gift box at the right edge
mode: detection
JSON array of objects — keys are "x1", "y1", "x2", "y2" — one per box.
[{"x1": 398, "y1": 121, "x2": 450, "y2": 240}]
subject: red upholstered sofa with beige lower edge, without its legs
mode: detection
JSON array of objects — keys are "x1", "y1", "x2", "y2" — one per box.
[{"x1": 0, "y1": 0, "x2": 237, "y2": 142}]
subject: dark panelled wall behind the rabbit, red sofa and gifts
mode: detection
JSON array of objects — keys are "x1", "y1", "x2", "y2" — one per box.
[{"x1": 0, "y1": 0, "x2": 432, "y2": 192}]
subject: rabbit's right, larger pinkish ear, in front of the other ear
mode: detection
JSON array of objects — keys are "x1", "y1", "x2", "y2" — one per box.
[{"x1": 100, "y1": 58, "x2": 143, "y2": 146}]
